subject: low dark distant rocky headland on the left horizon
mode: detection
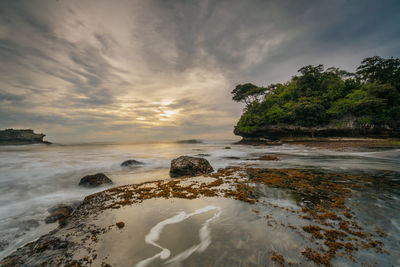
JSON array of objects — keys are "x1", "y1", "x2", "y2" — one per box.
[{"x1": 0, "y1": 129, "x2": 49, "y2": 145}]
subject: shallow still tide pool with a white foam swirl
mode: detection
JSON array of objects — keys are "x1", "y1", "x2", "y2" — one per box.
[{"x1": 95, "y1": 198, "x2": 305, "y2": 267}]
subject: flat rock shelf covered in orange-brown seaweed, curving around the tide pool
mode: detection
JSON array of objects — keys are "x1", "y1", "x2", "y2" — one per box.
[{"x1": 0, "y1": 158, "x2": 400, "y2": 266}]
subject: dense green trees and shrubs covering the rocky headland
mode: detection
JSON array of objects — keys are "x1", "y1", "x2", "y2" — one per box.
[{"x1": 231, "y1": 56, "x2": 400, "y2": 136}]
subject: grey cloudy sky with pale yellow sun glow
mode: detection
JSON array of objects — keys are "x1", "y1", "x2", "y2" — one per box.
[{"x1": 0, "y1": 0, "x2": 400, "y2": 142}]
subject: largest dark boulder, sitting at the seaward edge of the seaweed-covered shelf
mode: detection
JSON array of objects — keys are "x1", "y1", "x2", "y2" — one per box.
[{"x1": 169, "y1": 156, "x2": 214, "y2": 177}]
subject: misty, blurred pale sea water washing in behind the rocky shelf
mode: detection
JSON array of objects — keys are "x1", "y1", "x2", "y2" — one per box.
[{"x1": 0, "y1": 141, "x2": 400, "y2": 258}]
